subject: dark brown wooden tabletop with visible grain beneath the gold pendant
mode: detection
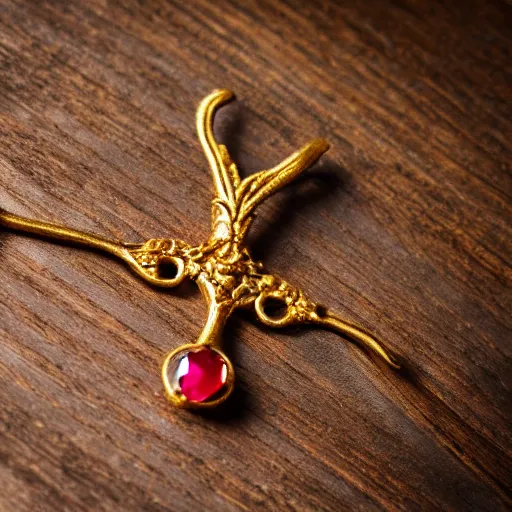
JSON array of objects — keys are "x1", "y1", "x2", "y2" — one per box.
[{"x1": 0, "y1": 0, "x2": 512, "y2": 512}]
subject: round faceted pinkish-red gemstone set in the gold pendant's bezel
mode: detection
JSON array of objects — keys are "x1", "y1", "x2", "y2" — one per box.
[{"x1": 176, "y1": 347, "x2": 228, "y2": 402}]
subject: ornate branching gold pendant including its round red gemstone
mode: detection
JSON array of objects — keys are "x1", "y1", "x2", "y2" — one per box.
[{"x1": 0, "y1": 90, "x2": 399, "y2": 408}]
